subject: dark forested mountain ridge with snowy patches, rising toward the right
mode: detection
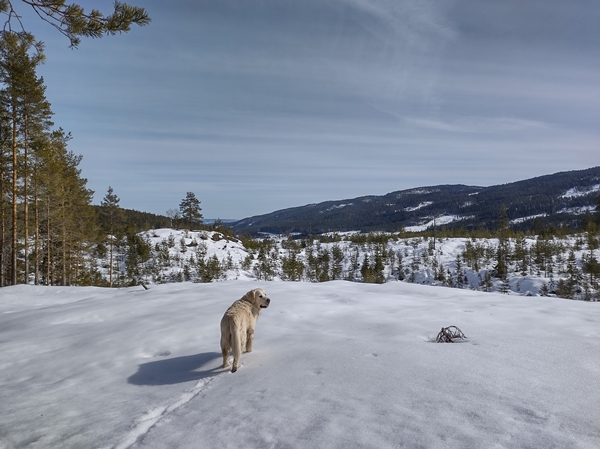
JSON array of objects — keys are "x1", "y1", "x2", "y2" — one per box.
[{"x1": 232, "y1": 167, "x2": 600, "y2": 235}]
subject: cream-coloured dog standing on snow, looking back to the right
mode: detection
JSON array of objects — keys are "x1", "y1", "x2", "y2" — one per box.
[{"x1": 221, "y1": 288, "x2": 271, "y2": 373}]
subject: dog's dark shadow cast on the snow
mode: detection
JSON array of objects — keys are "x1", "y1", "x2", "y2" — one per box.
[{"x1": 127, "y1": 352, "x2": 223, "y2": 385}]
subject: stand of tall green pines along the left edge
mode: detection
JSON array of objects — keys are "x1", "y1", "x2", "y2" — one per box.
[{"x1": 0, "y1": 31, "x2": 96, "y2": 286}]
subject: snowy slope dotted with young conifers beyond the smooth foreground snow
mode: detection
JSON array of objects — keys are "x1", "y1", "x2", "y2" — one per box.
[{"x1": 111, "y1": 229, "x2": 598, "y2": 300}]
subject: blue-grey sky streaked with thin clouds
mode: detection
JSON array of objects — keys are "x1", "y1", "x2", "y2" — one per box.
[{"x1": 14, "y1": 0, "x2": 600, "y2": 218}]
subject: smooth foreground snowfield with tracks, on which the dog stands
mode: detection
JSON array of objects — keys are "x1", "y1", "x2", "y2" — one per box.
[{"x1": 0, "y1": 281, "x2": 600, "y2": 449}]
